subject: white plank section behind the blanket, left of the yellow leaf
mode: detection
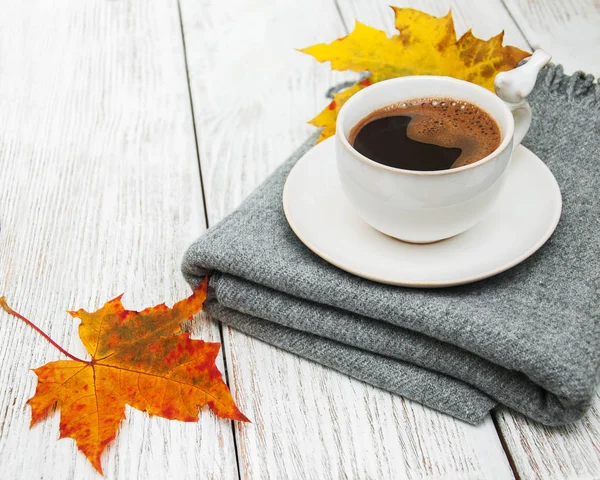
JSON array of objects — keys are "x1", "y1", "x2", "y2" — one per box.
[{"x1": 181, "y1": 0, "x2": 358, "y2": 224}]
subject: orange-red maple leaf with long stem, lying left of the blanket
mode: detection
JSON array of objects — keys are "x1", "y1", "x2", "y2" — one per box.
[{"x1": 0, "y1": 278, "x2": 249, "y2": 473}]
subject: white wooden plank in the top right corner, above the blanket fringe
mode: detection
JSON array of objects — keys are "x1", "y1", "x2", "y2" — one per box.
[{"x1": 504, "y1": 0, "x2": 600, "y2": 76}]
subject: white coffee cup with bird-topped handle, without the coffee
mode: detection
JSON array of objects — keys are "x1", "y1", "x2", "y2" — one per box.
[{"x1": 335, "y1": 50, "x2": 550, "y2": 243}]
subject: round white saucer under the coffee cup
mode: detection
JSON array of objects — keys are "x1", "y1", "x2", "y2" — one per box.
[{"x1": 283, "y1": 138, "x2": 562, "y2": 287}]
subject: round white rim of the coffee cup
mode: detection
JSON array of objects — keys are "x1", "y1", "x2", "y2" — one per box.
[{"x1": 335, "y1": 75, "x2": 515, "y2": 176}]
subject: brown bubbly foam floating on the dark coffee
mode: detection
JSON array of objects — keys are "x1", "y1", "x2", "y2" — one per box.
[{"x1": 349, "y1": 97, "x2": 502, "y2": 168}]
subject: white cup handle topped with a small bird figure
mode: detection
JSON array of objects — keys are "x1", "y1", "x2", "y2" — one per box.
[{"x1": 494, "y1": 50, "x2": 552, "y2": 150}]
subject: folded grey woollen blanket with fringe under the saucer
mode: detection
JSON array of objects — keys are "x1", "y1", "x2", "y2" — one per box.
[{"x1": 182, "y1": 66, "x2": 600, "y2": 425}]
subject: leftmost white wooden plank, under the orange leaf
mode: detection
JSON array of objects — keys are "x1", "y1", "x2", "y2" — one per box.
[{"x1": 0, "y1": 0, "x2": 237, "y2": 479}]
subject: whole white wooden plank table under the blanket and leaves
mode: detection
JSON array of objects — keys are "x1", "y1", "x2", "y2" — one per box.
[{"x1": 0, "y1": 0, "x2": 600, "y2": 480}]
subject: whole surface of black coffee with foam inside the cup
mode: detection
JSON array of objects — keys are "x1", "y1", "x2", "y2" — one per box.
[{"x1": 349, "y1": 98, "x2": 501, "y2": 171}]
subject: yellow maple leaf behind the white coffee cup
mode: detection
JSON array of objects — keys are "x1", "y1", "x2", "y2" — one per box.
[{"x1": 300, "y1": 7, "x2": 531, "y2": 141}]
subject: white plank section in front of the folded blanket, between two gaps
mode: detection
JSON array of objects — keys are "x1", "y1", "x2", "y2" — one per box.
[{"x1": 225, "y1": 329, "x2": 513, "y2": 479}]
